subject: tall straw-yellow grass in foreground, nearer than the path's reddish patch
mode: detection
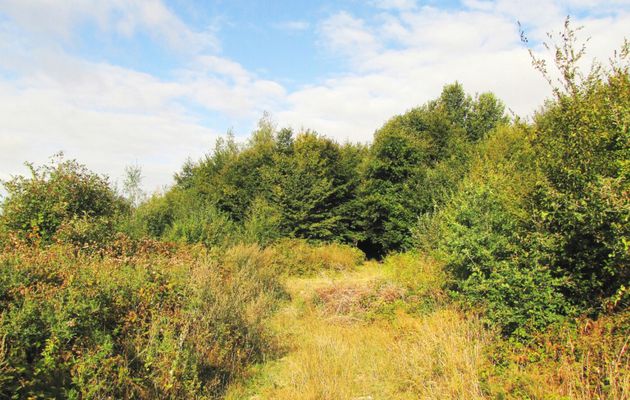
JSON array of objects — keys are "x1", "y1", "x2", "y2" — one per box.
[{"x1": 249, "y1": 310, "x2": 492, "y2": 399}]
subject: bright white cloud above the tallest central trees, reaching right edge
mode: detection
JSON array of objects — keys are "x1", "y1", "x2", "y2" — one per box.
[{"x1": 277, "y1": 0, "x2": 630, "y2": 141}]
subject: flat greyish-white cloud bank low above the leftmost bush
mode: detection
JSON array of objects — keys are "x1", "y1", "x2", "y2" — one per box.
[{"x1": 0, "y1": 78, "x2": 216, "y2": 194}]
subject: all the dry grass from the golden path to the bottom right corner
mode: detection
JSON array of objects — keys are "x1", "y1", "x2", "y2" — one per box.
[{"x1": 226, "y1": 254, "x2": 630, "y2": 400}]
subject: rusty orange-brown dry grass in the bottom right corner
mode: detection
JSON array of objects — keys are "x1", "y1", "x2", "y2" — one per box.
[{"x1": 488, "y1": 311, "x2": 630, "y2": 400}]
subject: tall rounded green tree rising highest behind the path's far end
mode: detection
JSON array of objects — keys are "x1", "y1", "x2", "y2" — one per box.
[{"x1": 361, "y1": 83, "x2": 507, "y2": 255}]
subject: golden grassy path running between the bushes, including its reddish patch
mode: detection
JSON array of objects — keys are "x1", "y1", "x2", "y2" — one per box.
[{"x1": 227, "y1": 263, "x2": 492, "y2": 400}]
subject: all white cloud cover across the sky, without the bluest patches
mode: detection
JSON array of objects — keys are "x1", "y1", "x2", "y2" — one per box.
[{"x1": 0, "y1": 0, "x2": 630, "y2": 189}]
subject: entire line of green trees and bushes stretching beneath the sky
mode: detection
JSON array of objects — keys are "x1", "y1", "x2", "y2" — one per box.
[{"x1": 0, "y1": 27, "x2": 630, "y2": 338}]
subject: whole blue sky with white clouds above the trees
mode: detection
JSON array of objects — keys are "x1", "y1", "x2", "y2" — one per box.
[{"x1": 0, "y1": 0, "x2": 630, "y2": 192}]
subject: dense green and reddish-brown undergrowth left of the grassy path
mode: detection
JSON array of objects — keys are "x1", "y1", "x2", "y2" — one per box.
[{"x1": 0, "y1": 245, "x2": 283, "y2": 399}]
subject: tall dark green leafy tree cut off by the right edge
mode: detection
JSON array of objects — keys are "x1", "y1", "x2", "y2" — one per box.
[{"x1": 532, "y1": 43, "x2": 630, "y2": 308}]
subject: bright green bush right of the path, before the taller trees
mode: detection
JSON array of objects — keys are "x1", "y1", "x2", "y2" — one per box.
[{"x1": 430, "y1": 184, "x2": 569, "y2": 338}]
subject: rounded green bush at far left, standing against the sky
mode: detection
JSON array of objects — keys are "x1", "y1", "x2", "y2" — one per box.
[{"x1": 0, "y1": 155, "x2": 128, "y2": 243}]
